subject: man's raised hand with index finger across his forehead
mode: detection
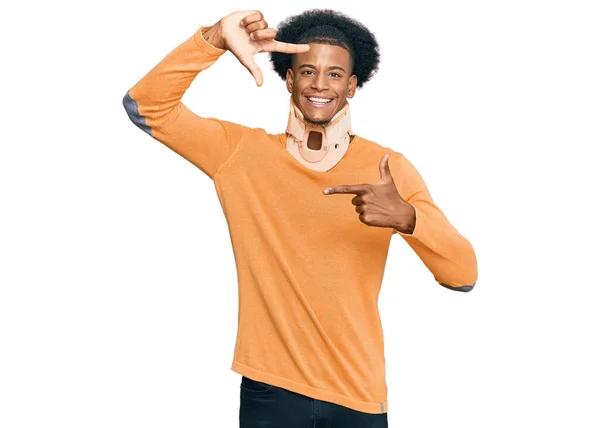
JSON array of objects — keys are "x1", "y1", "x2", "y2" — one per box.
[{"x1": 204, "y1": 10, "x2": 310, "y2": 86}]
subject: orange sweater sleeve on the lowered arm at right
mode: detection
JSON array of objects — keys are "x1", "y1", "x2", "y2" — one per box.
[{"x1": 390, "y1": 152, "x2": 478, "y2": 291}]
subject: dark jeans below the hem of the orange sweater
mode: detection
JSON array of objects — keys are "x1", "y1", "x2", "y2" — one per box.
[{"x1": 240, "y1": 376, "x2": 388, "y2": 428}]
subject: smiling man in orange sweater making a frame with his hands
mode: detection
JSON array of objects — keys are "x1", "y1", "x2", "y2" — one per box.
[{"x1": 123, "y1": 9, "x2": 477, "y2": 428}]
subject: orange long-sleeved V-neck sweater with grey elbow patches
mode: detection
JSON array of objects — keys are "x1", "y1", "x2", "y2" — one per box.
[{"x1": 123, "y1": 27, "x2": 477, "y2": 413}]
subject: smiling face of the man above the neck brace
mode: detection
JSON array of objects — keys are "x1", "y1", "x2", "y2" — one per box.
[{"x1": 286, "y1": 43, "x2": 357, "y2": 125}]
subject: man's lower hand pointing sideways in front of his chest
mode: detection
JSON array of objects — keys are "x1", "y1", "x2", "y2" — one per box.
[{"x1": 323, "y1": 154, "x2": 416, "y2": 233}]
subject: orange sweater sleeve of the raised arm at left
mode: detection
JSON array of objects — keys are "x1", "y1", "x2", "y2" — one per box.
[{"x1": 123, "y1": 26, "x2": 250, "y2": 179}]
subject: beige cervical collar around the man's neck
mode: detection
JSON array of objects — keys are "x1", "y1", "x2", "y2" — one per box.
[{"x1": 286, "y1": 97, "x2": 352, "y2": 171}]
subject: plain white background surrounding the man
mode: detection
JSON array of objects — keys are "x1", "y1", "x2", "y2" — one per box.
[{"x1": 0, "y1": 0, "x2": 600, "y2": 428}]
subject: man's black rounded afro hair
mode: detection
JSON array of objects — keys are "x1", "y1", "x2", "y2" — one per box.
[{"x1": 270, "y1": 9, "x2": 379, "y2": 88}]
